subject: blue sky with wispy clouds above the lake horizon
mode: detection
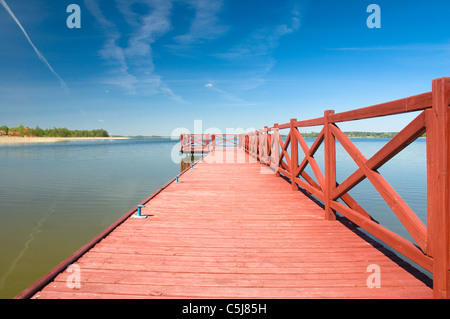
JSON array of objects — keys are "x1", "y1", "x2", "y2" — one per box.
[{"x1": 0, "y1": 0, "x2": 450, "y2": 135}]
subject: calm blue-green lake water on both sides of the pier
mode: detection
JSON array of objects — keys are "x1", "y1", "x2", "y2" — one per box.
[{"x1": 0, "y1": 139, "x2": 426, "y2": 298}]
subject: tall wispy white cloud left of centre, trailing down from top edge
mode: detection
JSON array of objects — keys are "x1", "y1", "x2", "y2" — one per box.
[{"x1": 85, "y1": 0, "x2": 186, "y2": 103}]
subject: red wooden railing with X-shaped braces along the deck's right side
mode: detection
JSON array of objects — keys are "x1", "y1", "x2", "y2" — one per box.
[{"x1": 239, "y1": 78, "x2": 450, "y2": 298}]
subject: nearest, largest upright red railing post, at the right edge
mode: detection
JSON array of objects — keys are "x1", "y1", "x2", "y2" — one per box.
[{"x1": 427, "y1": 78, "x2": 450, "y2": 298}]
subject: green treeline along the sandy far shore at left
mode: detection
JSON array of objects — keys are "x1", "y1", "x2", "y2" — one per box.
[{"x1": 0, "y1": 125, "x2": 109, "y2": 137}]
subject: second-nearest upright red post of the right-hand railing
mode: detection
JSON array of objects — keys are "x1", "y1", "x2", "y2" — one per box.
[{"x1": 324, "y1": 110, "x2": 336, "y2": 220}]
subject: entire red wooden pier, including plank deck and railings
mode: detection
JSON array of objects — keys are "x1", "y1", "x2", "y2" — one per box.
[{"x1": 16, "y1": 78, "x2": 450, "y2": 299}]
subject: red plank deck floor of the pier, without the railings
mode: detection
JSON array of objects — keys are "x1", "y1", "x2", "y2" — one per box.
[{"x1": 28, "y1": 150, "x2": 433, "y2": 299}]
